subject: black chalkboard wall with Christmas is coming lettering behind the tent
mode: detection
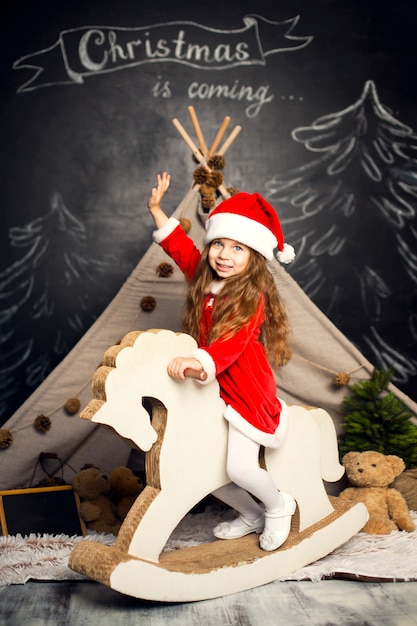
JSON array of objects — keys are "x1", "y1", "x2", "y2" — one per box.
[{"x1": 0, "y1": 0, "x2": 417, "y2": 423}]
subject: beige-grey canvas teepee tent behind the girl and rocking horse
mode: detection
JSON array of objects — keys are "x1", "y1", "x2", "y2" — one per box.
[{"x1": 0, "y1": 187, "x2": 417, "y2": 489}]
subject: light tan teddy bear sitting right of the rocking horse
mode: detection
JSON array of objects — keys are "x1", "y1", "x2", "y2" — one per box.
[{"x1": 339, "y1": 450, "x2": 415, "y2": 535}]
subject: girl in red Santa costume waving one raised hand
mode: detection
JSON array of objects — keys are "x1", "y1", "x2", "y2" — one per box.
[{"x1": 148, "y1": 172, "x2": 296, "y2": 551}]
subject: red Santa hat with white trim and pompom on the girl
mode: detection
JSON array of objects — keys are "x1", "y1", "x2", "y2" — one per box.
[{"x1": 205, "y1": 192, "x2": 295, "y2": 263}]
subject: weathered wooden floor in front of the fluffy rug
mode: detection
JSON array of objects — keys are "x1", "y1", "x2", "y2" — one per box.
[{"x1": 0, "y1": 580, "x2": 417, "y2": 626}]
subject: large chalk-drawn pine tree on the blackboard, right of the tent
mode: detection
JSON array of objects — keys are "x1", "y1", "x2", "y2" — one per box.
[{"x1": 267, "y1": 81, "x2": 417, "y2": 397}]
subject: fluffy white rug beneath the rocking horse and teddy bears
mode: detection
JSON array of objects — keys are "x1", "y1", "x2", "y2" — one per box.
[{"x1": 0, "y1": 506, "x2": 417, "y2": 586}]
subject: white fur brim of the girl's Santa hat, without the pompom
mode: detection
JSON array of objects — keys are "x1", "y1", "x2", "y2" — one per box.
[{"x1": 205, "y1": 212, "x2": 278, "y2": 261}]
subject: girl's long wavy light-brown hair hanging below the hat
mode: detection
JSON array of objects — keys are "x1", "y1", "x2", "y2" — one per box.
[{"x1": 182, "y1": 244, "x2": 291, "y2": 367}]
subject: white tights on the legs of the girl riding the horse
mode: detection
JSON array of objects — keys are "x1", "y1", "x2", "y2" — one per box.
[{"x1": 213, "y1": 423, "x2": 282, "y2": 521}]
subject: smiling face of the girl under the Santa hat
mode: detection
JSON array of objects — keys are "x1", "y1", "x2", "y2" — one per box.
[{"x1": 208, "y1": 238, "x2": 250, "y2": 278}]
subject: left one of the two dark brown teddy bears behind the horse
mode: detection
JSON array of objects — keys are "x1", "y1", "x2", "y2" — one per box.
[{"x1": 72, "y1": 467, "x2": 120, "y2": 535}]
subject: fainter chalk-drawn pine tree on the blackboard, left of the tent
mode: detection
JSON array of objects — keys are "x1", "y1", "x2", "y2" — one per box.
[{"x1": 0, "y1": 193, "x2": 113, "y2": 422}]
